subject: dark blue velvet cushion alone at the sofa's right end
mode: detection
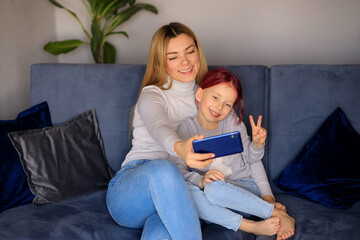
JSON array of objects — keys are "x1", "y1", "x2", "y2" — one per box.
[{"x1": 274, "y1": 108, "x2": 360, "y2": 208}]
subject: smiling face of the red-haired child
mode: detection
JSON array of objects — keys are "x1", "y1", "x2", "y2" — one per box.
[{"x1": 195, "y1": 83, "x2": 237, "y2": 130}]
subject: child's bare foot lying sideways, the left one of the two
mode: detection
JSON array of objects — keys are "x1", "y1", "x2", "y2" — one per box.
[{"x1": 239, "y1": 217, "x2": 280, "y2": 236}]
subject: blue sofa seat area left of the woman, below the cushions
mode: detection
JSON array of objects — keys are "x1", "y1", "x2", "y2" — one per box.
[{"x1": 0, "y1": 190, "x2": 141, "y2": 240}]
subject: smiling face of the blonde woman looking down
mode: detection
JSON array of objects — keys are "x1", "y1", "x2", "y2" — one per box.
[{"x1": 166, "y1": 33, "x2": 200, "y2": 83}]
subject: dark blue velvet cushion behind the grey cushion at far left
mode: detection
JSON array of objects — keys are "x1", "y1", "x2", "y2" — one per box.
[{"x1": 0, "y1": 102, "x2": 52, "y2": 212}]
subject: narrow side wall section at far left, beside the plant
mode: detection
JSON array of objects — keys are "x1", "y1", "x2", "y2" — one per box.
[{"x1": 0, "y1": 0, "x2": 57, "y2": 120}]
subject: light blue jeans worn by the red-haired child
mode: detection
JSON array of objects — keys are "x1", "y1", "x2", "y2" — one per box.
[{"x1": 188, "y1": 179, "x2": 274, "y2": 231}]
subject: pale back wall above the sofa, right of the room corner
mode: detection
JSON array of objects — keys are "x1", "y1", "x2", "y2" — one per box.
[{"x1": 56, "y1": 0, "x2": 360, "y2": 66}]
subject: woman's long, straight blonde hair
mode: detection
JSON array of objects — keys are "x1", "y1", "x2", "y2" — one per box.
[{"x1": 140, "y1": 22, "x2": 208, "y2": 92}]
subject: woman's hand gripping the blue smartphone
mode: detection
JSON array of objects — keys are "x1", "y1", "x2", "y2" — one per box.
[{"x1": 174, "y1": 135, "x2": 215, "y2": 168}]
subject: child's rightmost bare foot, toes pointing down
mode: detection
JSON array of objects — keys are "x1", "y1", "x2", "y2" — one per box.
[{"x1": 273, "y1": 208, "x2": 295, "y2": 240}]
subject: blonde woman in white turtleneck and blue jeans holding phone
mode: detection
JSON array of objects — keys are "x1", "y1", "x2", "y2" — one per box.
[{"x1": 107, "y1": 23, "x2": 214, "y2": 240}]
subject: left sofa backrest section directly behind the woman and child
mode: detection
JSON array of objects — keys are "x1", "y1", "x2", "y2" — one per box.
[{"x1": 31, "y1": 64, "x2": 269, "y2": 170}]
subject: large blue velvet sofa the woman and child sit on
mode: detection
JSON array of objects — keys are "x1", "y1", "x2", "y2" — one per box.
[{"x1": 0, "y1": 64, "x2": 360, "y2": 240}]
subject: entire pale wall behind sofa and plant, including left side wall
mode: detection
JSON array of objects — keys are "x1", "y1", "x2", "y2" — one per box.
[{"x1": 0, "y1": 0, "x2": 360, "y2": 119}]
